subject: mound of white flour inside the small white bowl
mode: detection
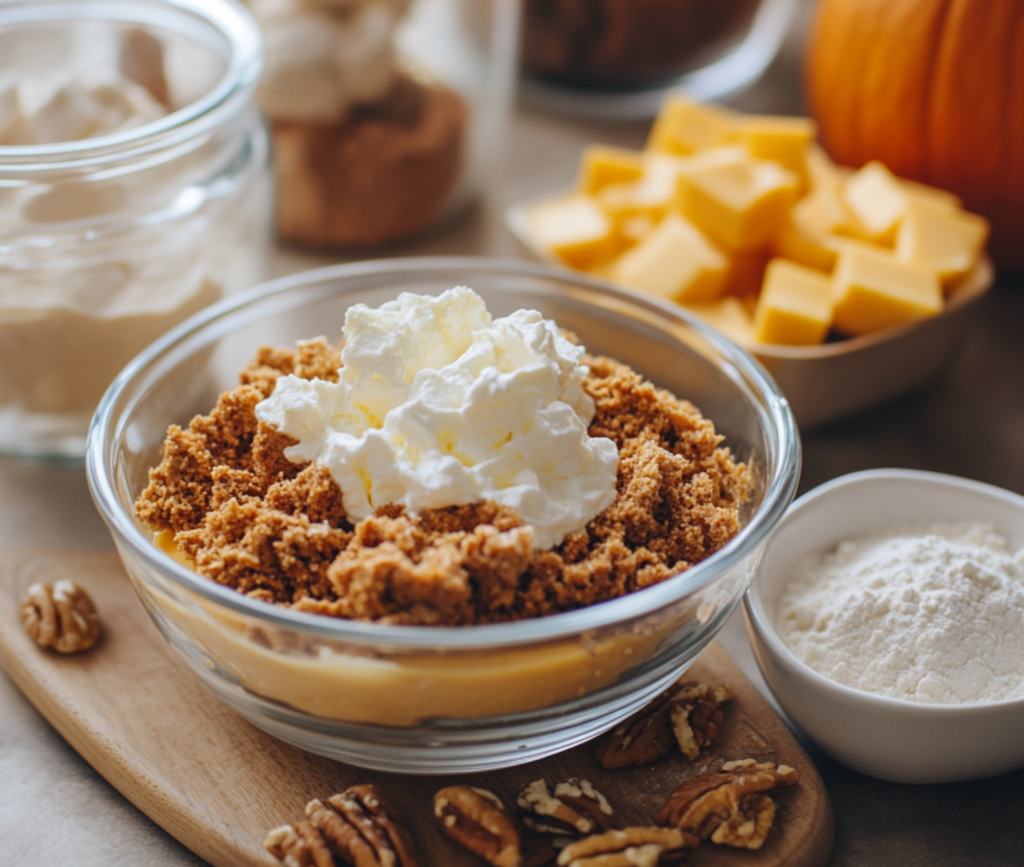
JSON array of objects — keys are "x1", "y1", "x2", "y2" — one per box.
[{"x1": 777, "y1": 524, "x2": 1024, "y2": 704}]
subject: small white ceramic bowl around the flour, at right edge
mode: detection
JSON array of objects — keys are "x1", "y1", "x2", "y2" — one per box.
[{"x1": 744, "y1": 470, "x2": 1024, "y2": 783}]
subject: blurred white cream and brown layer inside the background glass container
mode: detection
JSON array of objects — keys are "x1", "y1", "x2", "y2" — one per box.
[{"x1": 249, "y1": 0, "x2": 467, "y2": 247}]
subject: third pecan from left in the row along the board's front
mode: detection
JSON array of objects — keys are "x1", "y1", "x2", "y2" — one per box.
[{"x1": 516, "y1": 777, "x2": 613, "y2": 846}]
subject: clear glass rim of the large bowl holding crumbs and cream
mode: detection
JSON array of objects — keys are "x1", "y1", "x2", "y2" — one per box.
[{"x1": 85, "y1": 256, "x2": 801, "y2": 652}]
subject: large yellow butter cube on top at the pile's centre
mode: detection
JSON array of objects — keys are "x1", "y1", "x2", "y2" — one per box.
[{"x1": 677, "y1": 159, "x2": 798, "y2": 252}]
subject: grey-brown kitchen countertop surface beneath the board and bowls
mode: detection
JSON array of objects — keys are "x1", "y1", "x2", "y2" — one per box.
[{"x1": 0, "y1": 6, "x2": 1024, "y2": 867}]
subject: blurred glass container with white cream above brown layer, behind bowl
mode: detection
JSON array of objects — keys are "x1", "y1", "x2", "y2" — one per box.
[{"x1": 248, "y1": 0, "x2": 519, "y2": 250}]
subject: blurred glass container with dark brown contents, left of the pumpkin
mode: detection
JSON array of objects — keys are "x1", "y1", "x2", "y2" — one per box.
[{"x1": 521, "y1": 0, "x2": 796, "y2": 120}]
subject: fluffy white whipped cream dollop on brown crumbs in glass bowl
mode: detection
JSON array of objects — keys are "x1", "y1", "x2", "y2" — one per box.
[{"x1": 256, "y1": 287, "x2": 618, "y2": 549}]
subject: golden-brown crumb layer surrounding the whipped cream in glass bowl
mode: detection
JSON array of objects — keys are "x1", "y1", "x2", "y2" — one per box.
[{"x1": 135, "y1": 339, "x2": 753, "y2": 625}]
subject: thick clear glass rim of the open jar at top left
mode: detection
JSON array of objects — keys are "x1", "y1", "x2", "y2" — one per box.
[{"x1": 0, "y1": 0, "x2": 263, "y2": 164}]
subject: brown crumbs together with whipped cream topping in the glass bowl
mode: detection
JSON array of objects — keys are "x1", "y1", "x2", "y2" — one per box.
[{"x1": 136, "y1": 288, "x2": 753, "y2": 626}]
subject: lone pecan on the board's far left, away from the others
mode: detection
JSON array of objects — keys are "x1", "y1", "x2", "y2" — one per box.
[{"x1": 20, "y1": 580, "x2": 100, "y2": 653}]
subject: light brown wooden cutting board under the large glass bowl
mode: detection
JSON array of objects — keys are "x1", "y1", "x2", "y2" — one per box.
[{"x1": 0, "y1": 549, "x2": 833, "y2": 867}]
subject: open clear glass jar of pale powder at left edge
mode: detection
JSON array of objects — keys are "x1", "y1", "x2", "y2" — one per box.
[{"x1": 0, "y1": 0, "x2": 272, "y2": 462}]
